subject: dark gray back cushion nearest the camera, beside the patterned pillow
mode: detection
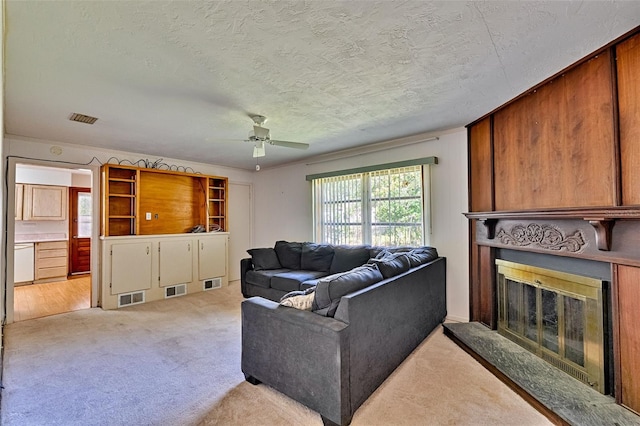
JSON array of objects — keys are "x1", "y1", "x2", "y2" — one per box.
[{"x1": 312, "y1": 265, "x2": 383, "y2": 317}]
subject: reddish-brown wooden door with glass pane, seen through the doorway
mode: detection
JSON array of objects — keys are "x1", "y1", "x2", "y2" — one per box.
[{"x1": 69, "y1": 187, "x2": 92, "y2": 274}]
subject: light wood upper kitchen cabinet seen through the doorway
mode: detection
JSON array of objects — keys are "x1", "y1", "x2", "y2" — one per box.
[{"x1": 22, "y1": 184, "x2": 68, "y2": 220}]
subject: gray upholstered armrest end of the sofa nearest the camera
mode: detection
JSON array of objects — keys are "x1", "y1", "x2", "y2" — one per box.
[{"x1": 241, "y1": 297, "x2": 351, "y2": 424}]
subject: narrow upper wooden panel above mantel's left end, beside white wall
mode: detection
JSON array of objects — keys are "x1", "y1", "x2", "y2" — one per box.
[{"x1": 469, "y1": 117, "x2": 493, "y2": 212}]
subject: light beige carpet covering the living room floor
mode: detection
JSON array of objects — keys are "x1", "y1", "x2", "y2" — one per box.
[{"x1": 0, "y1": 285, "x2": 550, "y2": 426}]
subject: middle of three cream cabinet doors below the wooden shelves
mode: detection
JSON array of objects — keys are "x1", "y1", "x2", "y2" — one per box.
[{"x1": 159, "y1": 240, "x2": 193, "y2": 287}]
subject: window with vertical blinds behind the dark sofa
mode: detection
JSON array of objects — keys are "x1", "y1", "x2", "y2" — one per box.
[{"x1": 307, "y1": 163, "x2": 433, "y2": 246}]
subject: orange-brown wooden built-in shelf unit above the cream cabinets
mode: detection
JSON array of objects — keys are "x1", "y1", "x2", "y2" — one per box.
[{"x1": 101, "y1": 164, "x2": 229, "y2": 236}]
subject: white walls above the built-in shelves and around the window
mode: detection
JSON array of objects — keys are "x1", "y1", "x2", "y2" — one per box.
[{"x1": 5, "y1": 129, "x2": 469, "y2": 321}]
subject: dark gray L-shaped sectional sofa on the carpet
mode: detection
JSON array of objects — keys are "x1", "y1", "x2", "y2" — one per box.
[{"x1": 242, "y1": 242, "x2": 446, "y2": 425}]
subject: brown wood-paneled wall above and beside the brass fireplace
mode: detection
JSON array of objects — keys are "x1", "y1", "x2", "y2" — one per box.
[{"x1": 468, "y1": 27, "x2": 640, "y2": 413}]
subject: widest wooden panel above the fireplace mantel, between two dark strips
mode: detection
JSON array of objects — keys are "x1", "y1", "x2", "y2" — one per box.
[{"x1": 493, "y1": 51, "x2": 617, "y2": 210}]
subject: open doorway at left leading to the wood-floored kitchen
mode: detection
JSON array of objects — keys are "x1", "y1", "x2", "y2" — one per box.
[{"x1": 7, "y1": 162, "x2": 97, "y2": 322}]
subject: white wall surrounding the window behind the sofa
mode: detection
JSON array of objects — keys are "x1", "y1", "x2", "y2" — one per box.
[{"x1": 254, "y1": 129, "x2": 469, "y2": 321}]
